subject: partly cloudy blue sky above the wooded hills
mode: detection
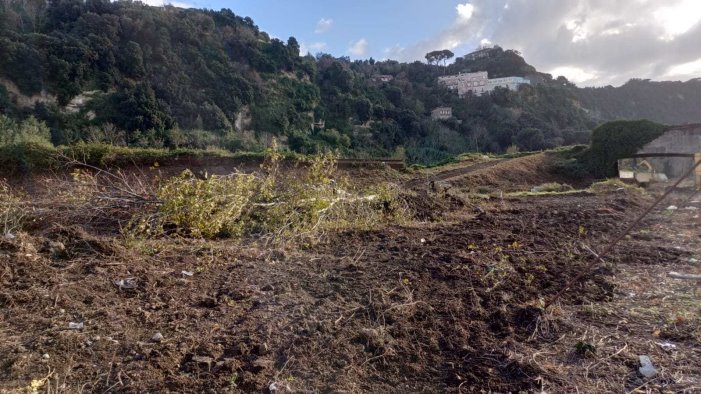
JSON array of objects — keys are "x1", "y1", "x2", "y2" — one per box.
[{"x1": 144, "y1": 0, "x2": 701, "y2": 86}]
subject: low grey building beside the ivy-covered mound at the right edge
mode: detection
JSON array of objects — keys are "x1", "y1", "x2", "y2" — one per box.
[{"x1": 618, "y1": 124, "x2": 701, "y2": 187}]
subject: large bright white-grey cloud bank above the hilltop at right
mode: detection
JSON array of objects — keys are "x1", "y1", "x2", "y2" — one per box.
[{"x1": 397, "y1": 0, "x2": 701, "y2": 85}]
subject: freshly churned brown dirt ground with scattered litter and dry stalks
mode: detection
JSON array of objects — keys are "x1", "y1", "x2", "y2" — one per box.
[{"x1": 0, "y1": 158, "x2": 701, "y2": 393}]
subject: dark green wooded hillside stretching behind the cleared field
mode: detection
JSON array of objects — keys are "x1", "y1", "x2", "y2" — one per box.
[{"x1": 0, "y1": 0, "x2": 701, "y2": 162}]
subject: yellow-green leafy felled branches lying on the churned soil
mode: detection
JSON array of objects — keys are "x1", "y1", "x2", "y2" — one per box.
[{"x1": 127, "y1": 143, "x2": 408, "y2": 239}]
